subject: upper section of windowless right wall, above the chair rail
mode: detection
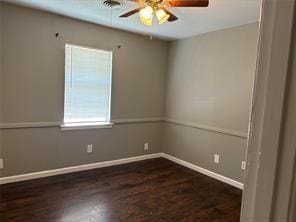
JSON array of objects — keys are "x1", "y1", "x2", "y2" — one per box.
[{"x1": 166, "y1": 23, "x2": 258, "y2": 132}]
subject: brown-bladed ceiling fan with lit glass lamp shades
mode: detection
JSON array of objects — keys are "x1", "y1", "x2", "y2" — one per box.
[{"x1": 119, "y1": 0, "x2": 209, "y2": 26}]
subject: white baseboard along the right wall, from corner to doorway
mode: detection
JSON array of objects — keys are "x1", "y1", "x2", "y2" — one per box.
[{"x1": 161, "y1": 153, "x2": 244, "y2": 190}]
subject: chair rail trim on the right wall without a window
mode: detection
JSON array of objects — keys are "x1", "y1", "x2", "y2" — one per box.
[{"x1": 164, "y1": 118, "x2": 248, "y2": 138}]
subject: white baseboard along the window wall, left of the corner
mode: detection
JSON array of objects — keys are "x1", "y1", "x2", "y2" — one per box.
[{"x1": 0, "y1": 153, "x2": 161, "y2": 184}]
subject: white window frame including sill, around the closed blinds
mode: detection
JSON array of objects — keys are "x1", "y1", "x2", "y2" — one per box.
[{"x1": 60, "y1": 43, "x2": 114, "y2": 130}]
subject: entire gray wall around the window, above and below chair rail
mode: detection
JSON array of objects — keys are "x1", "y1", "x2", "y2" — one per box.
[{"x1": 0, "y1": 3, "x2": 168, "y2": 176}]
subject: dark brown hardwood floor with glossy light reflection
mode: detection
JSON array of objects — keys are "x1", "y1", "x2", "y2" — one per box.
[{"x1": 0, "y1": 158, "x2": 241, "y2": 222}]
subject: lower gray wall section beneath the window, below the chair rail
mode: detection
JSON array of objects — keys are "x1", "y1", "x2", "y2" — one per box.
[{"x1": 2, "y1": 123, "x2": 162, "y2": 176}]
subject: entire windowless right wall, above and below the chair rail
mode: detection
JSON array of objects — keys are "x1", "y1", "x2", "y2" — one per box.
[{"x1": 163, "y1": 23, "x2": 258, "y2": 181}]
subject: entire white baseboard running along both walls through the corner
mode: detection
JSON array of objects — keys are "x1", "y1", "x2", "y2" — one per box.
[{"x1": 0, "y1": 153, "x2": 243, "y2": 189}]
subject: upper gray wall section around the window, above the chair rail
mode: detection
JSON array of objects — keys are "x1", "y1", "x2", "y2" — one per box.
[{"x1": 0, "y1": 3, "x2": 168, "y2": 123}]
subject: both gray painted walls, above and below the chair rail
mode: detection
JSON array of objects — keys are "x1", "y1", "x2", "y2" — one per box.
[{"x1": 0, "y1": 3, "x2": 258, "y2": 181}]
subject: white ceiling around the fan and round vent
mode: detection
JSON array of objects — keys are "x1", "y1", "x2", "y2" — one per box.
[{"x1": 4, "y1": 0, "x2": 261, "y2": 39}]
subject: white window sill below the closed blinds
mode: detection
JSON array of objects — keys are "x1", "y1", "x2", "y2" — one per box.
[{"x1": 60, "y1": 122, "x2": 114, "y2": 130}]
